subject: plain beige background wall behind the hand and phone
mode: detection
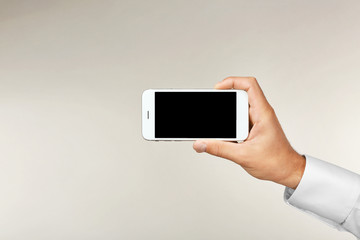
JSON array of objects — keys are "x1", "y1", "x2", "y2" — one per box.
[{"x1": 0, "y1": 0, "x2": 360, "y2": 240}]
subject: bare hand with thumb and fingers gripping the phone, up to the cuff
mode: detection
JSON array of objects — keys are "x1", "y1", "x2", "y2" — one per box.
[{"x1": 193, "y1": 77, "x2": 306, "y2": 189}]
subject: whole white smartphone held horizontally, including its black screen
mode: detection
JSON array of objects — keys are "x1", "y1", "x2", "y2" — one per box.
[{"x1": 142, "y1": 89, "x2": 249, "y2": 141}]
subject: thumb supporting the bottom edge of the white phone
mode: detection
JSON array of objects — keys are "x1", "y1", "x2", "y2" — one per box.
[{"x1": 193, "y1": 140, "x2": 241, "y2": 161}]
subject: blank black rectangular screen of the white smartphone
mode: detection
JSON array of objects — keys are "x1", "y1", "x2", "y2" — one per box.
[{"x1": 155, "y1": 92, "x2": 236, "y2": 138}]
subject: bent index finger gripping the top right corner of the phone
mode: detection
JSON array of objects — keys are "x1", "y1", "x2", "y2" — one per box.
[{"x1": 215, "y1": 77, "x2": 270, "y2": 111}]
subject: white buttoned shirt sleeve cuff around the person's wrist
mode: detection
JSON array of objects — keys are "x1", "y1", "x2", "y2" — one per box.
[{"x1": 284, "y1": 155, "x2": 360, "y2": 238}]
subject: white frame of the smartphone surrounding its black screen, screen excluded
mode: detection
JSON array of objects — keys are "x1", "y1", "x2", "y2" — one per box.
[{"x1": 142, "y1": 89, "x2": 249, "y2": 141}]
